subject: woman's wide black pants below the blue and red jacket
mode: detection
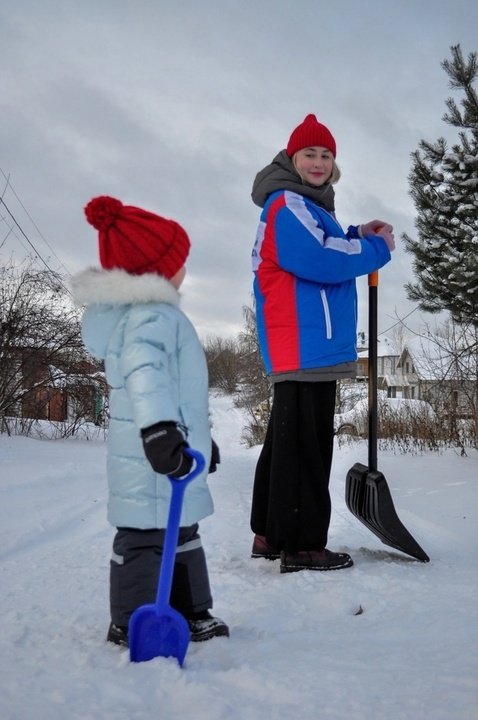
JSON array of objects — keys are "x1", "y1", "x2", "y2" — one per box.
[{"x1": 251, "y1": 381, "x2": 336, "y2": 553}]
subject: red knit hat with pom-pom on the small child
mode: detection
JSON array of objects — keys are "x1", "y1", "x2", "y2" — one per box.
[{"x1": 85, "y1": 195, "x2": 191, "y2": 280}]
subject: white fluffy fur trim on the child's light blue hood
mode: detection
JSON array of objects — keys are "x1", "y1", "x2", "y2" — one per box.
[{"x1": 70, "y1": 268, "x2": 179, "y2": 306}]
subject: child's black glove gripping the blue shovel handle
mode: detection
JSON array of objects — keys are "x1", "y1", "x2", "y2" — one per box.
[{"x1": 141, "y1": 421, "x2": 193, "y2": 477}]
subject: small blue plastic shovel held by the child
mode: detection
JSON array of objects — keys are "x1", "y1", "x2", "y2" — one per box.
[{"x1": 128, "y1": 448, "x2": 205, "y2": 667}]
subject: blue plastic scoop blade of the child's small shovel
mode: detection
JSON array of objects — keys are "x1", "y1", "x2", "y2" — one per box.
[{"x1": 128, "y1": 604, "x2": 190, "y2": 667}]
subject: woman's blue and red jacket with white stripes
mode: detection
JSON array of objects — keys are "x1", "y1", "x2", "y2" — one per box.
[{"x1": 252, "y1": 190, "x2": 391, "y2": 373}]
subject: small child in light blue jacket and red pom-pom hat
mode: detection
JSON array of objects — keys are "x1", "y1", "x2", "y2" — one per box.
[{"x1": 72, "y1": 196, "x2": 229, "y2": 646}]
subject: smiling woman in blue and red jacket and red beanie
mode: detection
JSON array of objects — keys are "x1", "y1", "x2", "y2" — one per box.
[{"x1": 251, "y1": 115, "x2": 395, "y2": 572}]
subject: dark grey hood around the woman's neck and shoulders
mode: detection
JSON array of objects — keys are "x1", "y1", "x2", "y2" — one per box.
[{"x1": 251, "y1": 150, "x2": 335, "y2": 212}]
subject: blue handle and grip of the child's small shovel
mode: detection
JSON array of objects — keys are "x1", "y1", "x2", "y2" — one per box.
[{"x1": 156, "y1": 448, "x2": 206, "y2": 610}]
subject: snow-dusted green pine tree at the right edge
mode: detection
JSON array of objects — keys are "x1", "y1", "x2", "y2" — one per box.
[{"x1": 402, "y1": 45, "x2": 478, "y2": 327}]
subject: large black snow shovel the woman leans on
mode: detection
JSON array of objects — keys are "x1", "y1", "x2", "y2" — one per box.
[{"x1": 345, "y1": 272, "x2": 430, "y2": 562}]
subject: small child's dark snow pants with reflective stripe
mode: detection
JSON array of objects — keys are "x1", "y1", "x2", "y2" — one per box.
[{"x1": 110, "y1": 524, "x2": 212, "y2": 627}]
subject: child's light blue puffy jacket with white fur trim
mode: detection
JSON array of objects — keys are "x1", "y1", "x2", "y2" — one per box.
[{"x1": 71, "y1": 269, "x2": 213, "y2": 529}]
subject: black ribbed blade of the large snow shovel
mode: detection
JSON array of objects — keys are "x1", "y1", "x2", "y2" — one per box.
[{"x1": 345, "y1": 463, "x2": 430, "y2": 562}]
